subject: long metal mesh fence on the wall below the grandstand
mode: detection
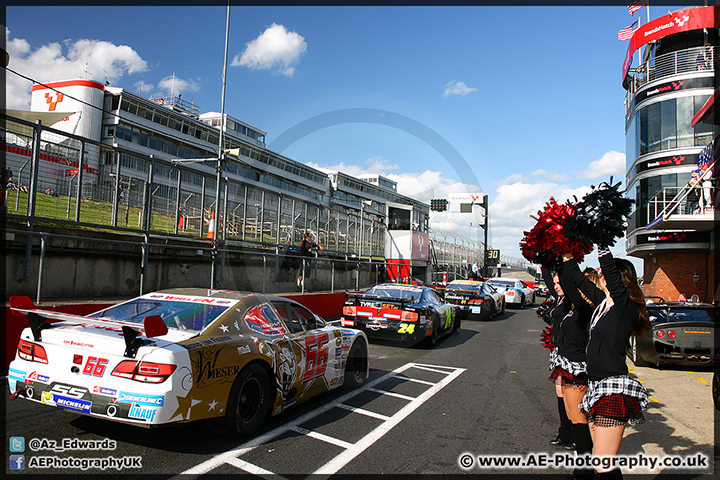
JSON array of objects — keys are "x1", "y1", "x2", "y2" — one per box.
[{"x1": 2, "y1": 116, "x2": 385, "y2": 256}]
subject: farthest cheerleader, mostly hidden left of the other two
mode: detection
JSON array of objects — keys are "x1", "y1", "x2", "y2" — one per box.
[{"x1": 541, "y1": 266, "x2": 575, "y2": 450}]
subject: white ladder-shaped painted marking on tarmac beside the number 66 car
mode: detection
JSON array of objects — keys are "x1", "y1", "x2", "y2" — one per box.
[{"x1": 173, "y1": 363, "x2": 465, "y2": 480}]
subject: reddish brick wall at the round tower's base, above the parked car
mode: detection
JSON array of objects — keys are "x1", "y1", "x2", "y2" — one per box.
[{"x1": 643, "y1": 251, "x2": 715, "y2": 303}]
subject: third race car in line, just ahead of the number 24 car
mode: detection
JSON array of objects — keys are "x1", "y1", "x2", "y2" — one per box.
[{"x1": 441, "y1": 280, "x2": 505, "y2": 320}]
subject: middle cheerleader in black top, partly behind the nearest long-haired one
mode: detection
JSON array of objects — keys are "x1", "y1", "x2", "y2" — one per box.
[{"x1": 551, "y1": 262, "x2": 599, "y2": 479}]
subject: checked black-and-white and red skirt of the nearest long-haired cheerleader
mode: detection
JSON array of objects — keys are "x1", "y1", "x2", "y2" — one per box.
[{"x1": 578, "y1": 375, "x2": 650, "y2": 427}]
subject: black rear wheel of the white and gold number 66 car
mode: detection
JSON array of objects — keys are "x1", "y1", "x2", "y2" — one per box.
[{"x1": 209, "y1": 363, "x2": 272, "y2": 437}]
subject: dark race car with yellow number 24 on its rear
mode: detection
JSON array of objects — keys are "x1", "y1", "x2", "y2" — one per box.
[{"x1": 341, "y1": 283, "x2": 460, "y2": 346}]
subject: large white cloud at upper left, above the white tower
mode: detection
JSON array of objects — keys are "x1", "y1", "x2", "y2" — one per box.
[{"x1": 5, "y1": 29, "x2": 148, "y2": 109}]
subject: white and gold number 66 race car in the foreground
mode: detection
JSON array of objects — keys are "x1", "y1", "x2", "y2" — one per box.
[{"x1": 8, "y1": 288, "x2": 369, "y2": 436}]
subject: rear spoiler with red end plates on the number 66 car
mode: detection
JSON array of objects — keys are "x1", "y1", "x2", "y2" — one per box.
[{"x1": 10, "y1": 296, "x2": 168, "y2": 358}]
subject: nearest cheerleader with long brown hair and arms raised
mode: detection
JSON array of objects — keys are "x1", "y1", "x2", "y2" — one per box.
[{"x1": 563, "y1": 246, "x2": 650, "y2": 478}]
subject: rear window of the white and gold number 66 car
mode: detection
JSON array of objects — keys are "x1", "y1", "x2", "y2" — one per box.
[{"x1": 88, "y1": 298, "x2": 235, "y2": 332}]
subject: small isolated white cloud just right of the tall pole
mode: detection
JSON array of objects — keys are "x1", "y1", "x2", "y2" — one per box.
[{"x1": 231, "y1": 23, "x2": 307, "y2": 77}]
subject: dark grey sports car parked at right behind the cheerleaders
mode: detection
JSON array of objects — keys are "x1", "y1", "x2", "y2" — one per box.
[{"x1": 627, "y1": 301, "x2": 720, "y2": 367}]
